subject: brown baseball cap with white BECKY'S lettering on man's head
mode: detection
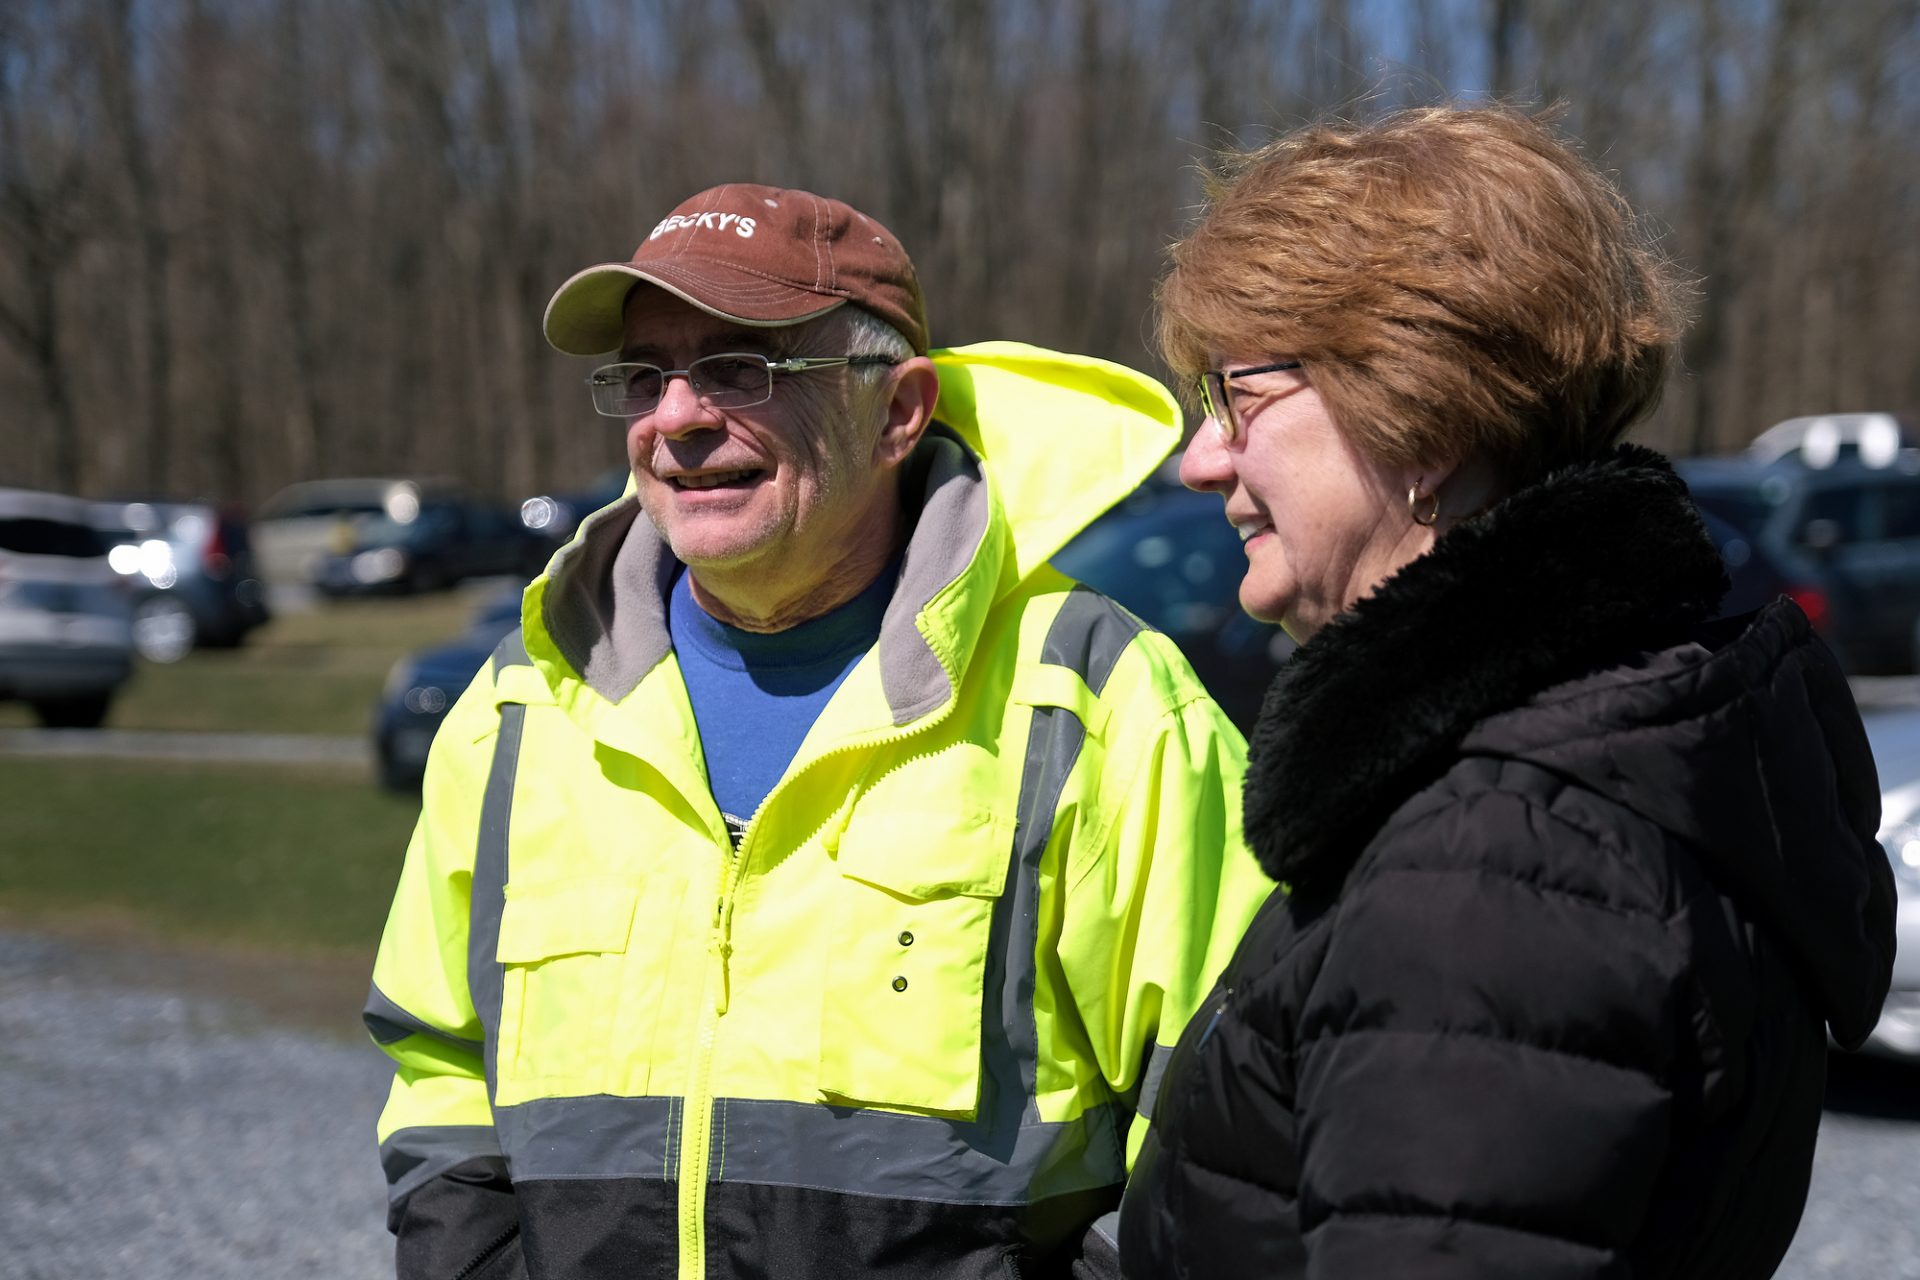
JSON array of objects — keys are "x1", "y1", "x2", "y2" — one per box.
[{"x1": 545, "y1": 182, "x2": 927, "y2": 355}]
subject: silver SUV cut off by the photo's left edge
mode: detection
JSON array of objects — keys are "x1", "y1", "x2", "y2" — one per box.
[{"x1": 0, "y1": 489, "x2": 132, "y2": 729}]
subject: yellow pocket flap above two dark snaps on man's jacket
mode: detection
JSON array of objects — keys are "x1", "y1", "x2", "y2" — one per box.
[{"x1": 839, "y1": 808, "x2": 1014, "y2": 900}]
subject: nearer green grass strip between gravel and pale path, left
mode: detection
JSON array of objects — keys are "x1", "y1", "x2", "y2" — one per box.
[{"x1": 0, "y1": 756, "x2": 419, "y2": 956}]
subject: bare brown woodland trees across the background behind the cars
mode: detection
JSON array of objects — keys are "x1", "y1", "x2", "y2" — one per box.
[{"x1": 0, "y1": 0, "x2": 1920, "y2": 499}]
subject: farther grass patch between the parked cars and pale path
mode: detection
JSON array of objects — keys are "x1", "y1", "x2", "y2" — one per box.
[{"x1": 0, "y1": 587, "x2": 493, "y2": 737}]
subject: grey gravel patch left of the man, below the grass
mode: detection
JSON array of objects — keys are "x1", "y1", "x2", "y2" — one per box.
[{"x1": 0, "y1": 933, "x2": 392, "y2": 1280}]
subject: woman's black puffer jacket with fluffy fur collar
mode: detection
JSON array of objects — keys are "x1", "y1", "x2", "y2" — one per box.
[{"x1": 1121, "y1": 447, "x2": 1893, "y2": 1280}]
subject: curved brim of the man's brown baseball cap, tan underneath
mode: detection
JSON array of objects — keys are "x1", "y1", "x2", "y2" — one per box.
[{"x1": 541, "y1": 259, "x2": 847, "y2": 355}]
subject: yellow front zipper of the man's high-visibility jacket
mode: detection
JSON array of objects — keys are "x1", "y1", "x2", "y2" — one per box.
[{"x1": 680, "y1": 699, "x2": 954, "y2": 1280}]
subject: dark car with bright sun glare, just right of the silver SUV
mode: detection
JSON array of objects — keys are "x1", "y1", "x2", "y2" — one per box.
[{"x1": 94, "y1": 503, "x2": 273, "y2": 662}]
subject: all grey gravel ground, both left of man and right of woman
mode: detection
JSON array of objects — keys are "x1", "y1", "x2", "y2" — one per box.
[{"x1": 0, "y1": 929, "x2": 1920, "y2": 1280}]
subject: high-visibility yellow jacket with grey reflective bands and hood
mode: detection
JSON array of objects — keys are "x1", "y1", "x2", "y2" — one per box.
[{"x1": 367, "y1": 344, "x2": 1273, "y2": 1280}]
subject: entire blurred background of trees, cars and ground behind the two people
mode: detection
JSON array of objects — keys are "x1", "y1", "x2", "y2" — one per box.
[{"x1": 0, "y1": 0, "x2": 1920, "y2": 1276}]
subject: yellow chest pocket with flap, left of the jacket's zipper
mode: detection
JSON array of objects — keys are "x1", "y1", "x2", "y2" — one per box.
[{"x1": 495, "y1": 877, "x2": 672, "y2": 1105}]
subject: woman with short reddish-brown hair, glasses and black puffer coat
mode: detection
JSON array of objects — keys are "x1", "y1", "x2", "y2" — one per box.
[{"x1": 1121, "y1": 107, "x2": 1893, "y2": 1280}]
